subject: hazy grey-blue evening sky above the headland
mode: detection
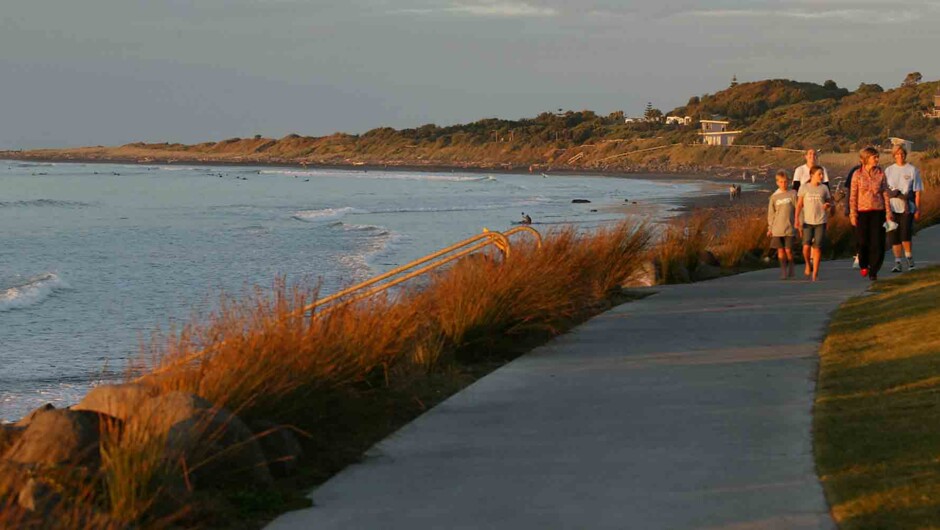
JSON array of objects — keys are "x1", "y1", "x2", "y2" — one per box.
[{"x1": 0, "y1": 0, "x2": 940, "y2": 149}]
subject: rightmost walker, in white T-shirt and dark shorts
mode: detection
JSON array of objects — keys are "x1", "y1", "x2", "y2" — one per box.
[{"x1": 885, "y1": 145, "x2": 924, "y2": 272}]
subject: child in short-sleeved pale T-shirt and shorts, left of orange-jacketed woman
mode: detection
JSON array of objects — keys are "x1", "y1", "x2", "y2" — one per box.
[{"x1": 793, "y1": 166, "x2": 832, "y2": 282}]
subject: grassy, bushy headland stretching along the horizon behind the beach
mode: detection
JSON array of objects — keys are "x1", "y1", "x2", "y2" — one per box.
[{"x1": 0, "y1": 79, "x2": 940, "y2": 174}]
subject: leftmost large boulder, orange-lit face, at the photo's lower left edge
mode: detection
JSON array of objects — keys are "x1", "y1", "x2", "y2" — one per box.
[{"x1": 4, "y1": 409, "x2": 109, "y2": 467}]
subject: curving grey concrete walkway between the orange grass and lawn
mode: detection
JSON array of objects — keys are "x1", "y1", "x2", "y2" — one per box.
[{"x1": 270, "y1": 227, "x2": 940, "y2": 530}]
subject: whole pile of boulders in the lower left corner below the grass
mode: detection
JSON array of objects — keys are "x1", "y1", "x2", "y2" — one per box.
[{"x1": 0, "y1": 383, "x2": 302, "y2": 515}]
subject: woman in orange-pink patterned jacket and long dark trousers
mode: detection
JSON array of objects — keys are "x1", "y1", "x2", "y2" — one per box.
[{"x1": 849, "y1": 143, "x2": 894, "y2": 280}]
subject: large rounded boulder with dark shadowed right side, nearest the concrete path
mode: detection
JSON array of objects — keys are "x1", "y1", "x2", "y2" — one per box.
[{"x1": 136, "y1": 392, "x2": 274, "y2": 486}]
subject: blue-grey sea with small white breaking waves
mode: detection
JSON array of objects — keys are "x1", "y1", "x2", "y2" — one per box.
[{"x1": 0, "y1": 161, "x2": 707, "y2": 420}]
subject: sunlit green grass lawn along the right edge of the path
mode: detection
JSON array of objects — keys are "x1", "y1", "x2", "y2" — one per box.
[{"x1": 814, "y1": 267, "x2": 940, "y2": 529}]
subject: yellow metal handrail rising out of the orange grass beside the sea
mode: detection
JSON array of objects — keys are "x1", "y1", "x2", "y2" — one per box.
[{"x1": 144, "y1": 226, "x2": 542, "y2": 380}]
